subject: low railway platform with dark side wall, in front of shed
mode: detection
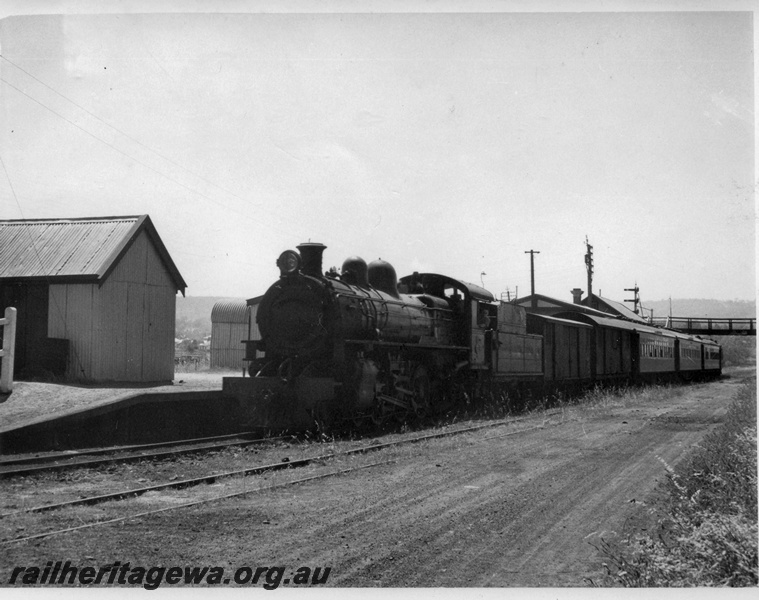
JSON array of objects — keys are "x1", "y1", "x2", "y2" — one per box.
[{"x1": 0, "y1": 373, "x2": 286, "y2": 455}]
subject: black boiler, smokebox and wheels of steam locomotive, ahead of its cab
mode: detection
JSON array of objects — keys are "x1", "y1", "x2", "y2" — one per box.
[{"x1": 249, "y1": 243, "x2": 467, "y2": 419}]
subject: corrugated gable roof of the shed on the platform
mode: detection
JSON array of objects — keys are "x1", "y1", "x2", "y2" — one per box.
[{"x1": 0, "y1": 215, "x2": 187, "y2": 294}]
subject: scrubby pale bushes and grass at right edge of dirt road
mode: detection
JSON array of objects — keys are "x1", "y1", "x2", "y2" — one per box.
[{"x1": 601, "y1": 385, "x2": 759, "y2": 587}]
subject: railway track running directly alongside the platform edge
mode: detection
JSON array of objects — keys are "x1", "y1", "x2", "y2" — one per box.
[{"x1": 0, "y1": 432, "x2": 285, "y2": 479}]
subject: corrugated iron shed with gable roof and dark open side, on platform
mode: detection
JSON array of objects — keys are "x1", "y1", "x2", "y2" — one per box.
[{"x1": 0, "y1": 215, "x2": 186, "y2": 382}]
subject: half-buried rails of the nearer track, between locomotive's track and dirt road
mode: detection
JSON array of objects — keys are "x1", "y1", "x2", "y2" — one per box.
[{"x1": 0, "y1": 418, "x2": 560, "y2": 544}]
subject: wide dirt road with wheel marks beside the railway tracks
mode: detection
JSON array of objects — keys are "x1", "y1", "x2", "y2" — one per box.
[{"x1": 0, "y1": 379, "x2": 740, "y2": 587}]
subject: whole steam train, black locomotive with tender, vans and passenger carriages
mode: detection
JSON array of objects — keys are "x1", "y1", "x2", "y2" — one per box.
[{"x1": 236, "y1": 243, "x2": 721, "y2": 421}]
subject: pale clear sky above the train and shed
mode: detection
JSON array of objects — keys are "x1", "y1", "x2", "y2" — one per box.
[{"x1": 0, "y1": 0, "x2": 756, "y2": 305}]
